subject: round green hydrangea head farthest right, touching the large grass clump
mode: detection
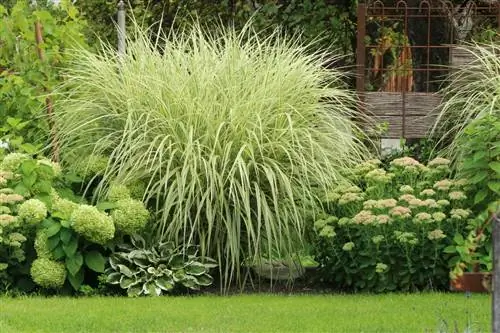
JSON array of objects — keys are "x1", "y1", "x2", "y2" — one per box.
[{"x1": 111, "y1": 199, "x2": 149, "y2": 235}]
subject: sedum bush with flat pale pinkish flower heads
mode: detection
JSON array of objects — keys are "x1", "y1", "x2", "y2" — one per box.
[{"x1": 314, "y1": 157, "x2": 473, "y2": 292}]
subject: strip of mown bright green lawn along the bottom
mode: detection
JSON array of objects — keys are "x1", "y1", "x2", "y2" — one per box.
[{"x1": 0, "y1": 293, "x2": 491, "y2": 333}]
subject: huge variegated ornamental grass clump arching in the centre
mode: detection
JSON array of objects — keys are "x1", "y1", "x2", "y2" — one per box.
[{"x1": 55, "y1": 21, "x2": 365, "y2": 282}]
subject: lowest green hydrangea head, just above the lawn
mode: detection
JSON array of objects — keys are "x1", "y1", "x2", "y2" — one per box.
[{"x1": 30, "y1": 258, "x2": 66, "y2": 289}]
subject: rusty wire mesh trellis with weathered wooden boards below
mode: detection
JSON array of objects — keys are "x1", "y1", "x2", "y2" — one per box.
[{"x1": 356, "y1": 0, "x2": 500, "y2": 138}]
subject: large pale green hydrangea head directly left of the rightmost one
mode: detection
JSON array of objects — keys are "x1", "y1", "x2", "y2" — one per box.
[{"x1": 70, "y1": 205, "x2": 115, "y2": 245}]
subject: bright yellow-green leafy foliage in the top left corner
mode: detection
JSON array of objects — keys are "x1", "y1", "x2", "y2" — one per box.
[{"x1": 0, "y1": 0, "x2": 85, "y2": 153}]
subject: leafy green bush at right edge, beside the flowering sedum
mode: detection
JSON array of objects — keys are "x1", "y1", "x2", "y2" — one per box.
[{"x1": 446, "y1": 115, "x2": 500, "y2": 278}]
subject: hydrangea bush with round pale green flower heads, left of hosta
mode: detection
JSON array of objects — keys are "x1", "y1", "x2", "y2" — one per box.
[{"x1": 0, "y1": 153, "x2": 147, "y2": 291}]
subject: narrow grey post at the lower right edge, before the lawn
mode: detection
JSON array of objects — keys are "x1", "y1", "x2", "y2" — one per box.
[{"x1": 491, "y1": 211, "x2": 500, "y2": 333}]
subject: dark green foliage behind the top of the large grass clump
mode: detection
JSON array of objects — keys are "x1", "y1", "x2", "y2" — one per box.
[{"x1": 76, "y1": 0, "x2": 356, "y2": 54}]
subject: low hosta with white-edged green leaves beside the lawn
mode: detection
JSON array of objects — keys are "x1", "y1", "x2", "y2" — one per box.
[{"x1": 106, "y1": 236, "x2": 216, "y2": 296}]
